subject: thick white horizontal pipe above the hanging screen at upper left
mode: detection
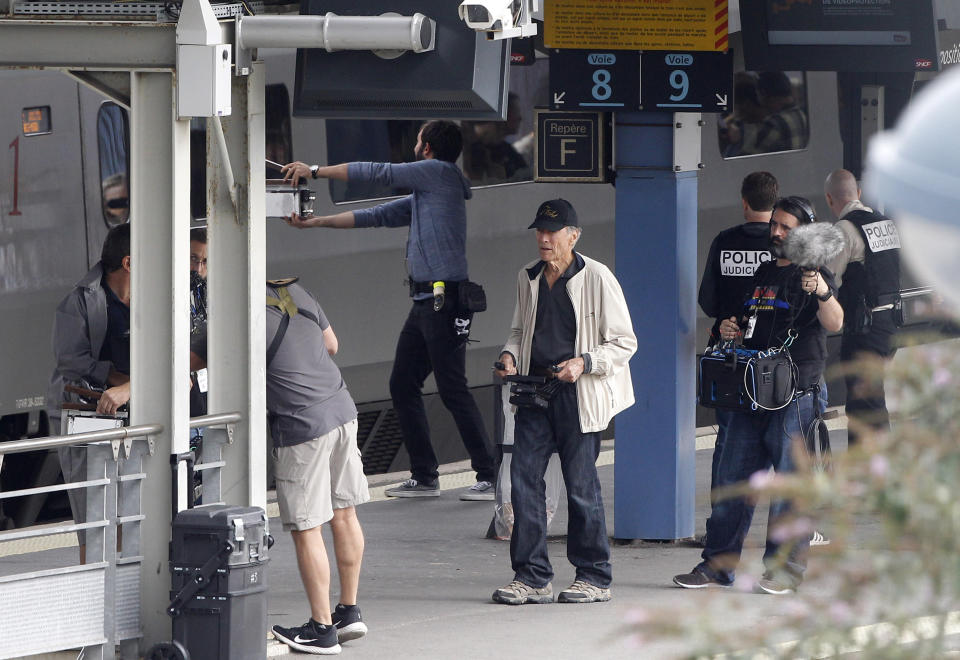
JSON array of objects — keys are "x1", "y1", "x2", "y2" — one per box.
[{"x1": 237, "y1": 12, "x2": 436, "y2": 53}]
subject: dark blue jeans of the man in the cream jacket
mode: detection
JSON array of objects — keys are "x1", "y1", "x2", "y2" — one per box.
[{"x1": 510, "y1": 384, "x2": 612, "y2": 588}]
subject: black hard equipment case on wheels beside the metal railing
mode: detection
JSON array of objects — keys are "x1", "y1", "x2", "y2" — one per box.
[{"x1": 168, "y1": 504, "x2": 272, "y2": 660}]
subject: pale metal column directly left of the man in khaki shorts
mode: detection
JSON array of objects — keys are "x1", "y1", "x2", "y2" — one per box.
[{"x1": 207, "y1": 62, "x2": 267, "y2": 508}]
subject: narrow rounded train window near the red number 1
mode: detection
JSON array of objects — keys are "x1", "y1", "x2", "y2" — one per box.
[{"x1": 97, "y1": 102, "x2": 130, "y2": 227}]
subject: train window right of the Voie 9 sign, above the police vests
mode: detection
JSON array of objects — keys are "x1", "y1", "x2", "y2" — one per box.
[{"x1": 717, "y1": 71, "x2": 810, "y2": 158}]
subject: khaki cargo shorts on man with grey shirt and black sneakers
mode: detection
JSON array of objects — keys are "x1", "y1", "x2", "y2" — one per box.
[{"x1": 273, "y1": 419, "x2": 370, "y2": 531}]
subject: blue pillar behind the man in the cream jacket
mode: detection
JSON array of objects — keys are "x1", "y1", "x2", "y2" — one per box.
[{"x1": 613, "y1": 112, "x2": 699, "y2": 540}]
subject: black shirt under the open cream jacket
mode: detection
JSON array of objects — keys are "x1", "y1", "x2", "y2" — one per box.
[{"x1": 530, "y1": 253, "x2": 584, "y2": 369}]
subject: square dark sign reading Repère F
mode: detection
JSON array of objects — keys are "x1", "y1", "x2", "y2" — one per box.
[{"x1": 533, "y1": 110, "x2": 606, "y2": 183}]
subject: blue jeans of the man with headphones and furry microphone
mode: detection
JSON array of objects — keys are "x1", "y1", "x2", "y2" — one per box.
[{"x1": 702, "y1": 392, "x2": 820, "y2": 584}]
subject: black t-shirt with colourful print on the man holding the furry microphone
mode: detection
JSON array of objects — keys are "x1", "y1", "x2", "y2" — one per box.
[{"x1": 740, "y1": 261, "x2": 837, "y2": 389}]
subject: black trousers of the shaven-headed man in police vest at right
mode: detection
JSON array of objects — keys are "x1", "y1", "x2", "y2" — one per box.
[{"x1": 840, "y1": 335, "x2": 892, "y2": 447}]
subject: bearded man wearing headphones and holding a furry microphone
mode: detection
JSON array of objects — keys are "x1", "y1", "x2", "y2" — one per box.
[{"x1": 673, "y1": 196, "x2": 843, "y2": 594}]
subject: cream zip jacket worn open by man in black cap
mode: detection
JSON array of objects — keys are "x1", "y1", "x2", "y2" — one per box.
[{"x1": 503, "y1": 255, "x2": 637, "y2": 433}]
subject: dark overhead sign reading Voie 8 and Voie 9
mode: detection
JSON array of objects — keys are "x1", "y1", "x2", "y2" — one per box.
[{"x1": 550, "y1": 49, "x2": 733, "y2": 112}]
